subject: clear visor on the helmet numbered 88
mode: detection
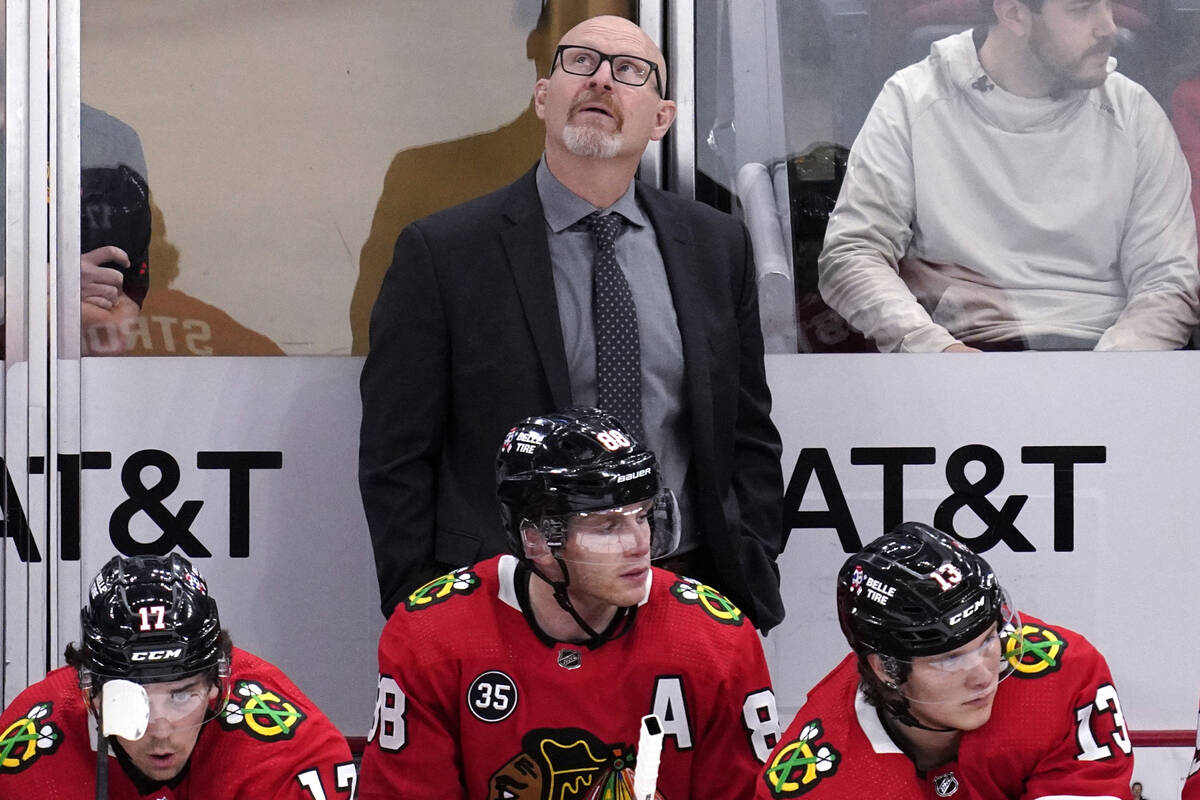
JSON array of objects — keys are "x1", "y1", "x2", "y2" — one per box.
[{"x1": 545, "y1": 488, "x2": 679, "y2": 564}]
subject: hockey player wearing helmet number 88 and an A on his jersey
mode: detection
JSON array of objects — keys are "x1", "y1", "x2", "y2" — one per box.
[{"x1": 359, "y1": 409, "x2": 779, "y2": 800}]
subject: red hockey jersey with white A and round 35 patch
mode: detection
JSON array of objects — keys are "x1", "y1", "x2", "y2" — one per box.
[{"x1": 359, "y1": 555, "x2": 779, "y2": 800}]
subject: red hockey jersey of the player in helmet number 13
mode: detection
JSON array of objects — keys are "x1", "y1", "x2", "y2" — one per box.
[{"x1": 756, "y1": 616, "x2": 1133, "y2": 800}]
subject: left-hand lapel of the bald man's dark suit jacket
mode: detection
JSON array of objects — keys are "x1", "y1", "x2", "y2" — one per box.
[{"x1": 500, "y1": 170, "x2": 571, "y2": 408}]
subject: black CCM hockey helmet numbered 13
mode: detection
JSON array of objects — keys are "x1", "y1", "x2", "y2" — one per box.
[{"x1": 838, "y1": 522, "x2": 1010, "y2": 661}]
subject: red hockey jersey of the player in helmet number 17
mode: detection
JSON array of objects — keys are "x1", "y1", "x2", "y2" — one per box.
[{"x1": 0, "y1": 648, "x2": 355, "y2": 800}]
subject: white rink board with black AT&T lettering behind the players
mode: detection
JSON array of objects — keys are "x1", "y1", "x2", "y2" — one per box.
[{"x1": 54, "y1": 353, "x2": 1200, "y2": 735}]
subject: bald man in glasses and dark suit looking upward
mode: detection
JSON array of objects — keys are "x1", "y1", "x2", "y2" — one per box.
[{"x1": 359, "y1": 16, "x2": 784, "y2": 631}]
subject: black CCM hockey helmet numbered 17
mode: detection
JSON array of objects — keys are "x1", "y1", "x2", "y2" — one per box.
[{"x1": 79, "y1": 553, "x2": 228, "y2": 684}]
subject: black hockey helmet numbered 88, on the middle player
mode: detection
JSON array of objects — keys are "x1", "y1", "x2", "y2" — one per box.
[{"x1": 496, "y1": 408, "x2": 679, "y2": 558}]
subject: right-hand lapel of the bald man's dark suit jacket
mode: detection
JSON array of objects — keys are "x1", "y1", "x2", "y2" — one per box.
[{"x1": 637, "y1": 181, "x2": 715, "y2": 463}]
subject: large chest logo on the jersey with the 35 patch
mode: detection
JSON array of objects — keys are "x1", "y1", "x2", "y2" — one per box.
[{"x1": 487, "y1": 728, "x2": 666, "y2": 800}]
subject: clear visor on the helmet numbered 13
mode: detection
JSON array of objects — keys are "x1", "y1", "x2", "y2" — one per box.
[{"x1": 881, "y1": 593, "x2": 1022, "y2": 705}]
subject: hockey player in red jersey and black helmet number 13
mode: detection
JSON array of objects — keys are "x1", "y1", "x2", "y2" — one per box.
[{"x1": 756, "y1": 522, "x2": 1133, "y2": 800}]
